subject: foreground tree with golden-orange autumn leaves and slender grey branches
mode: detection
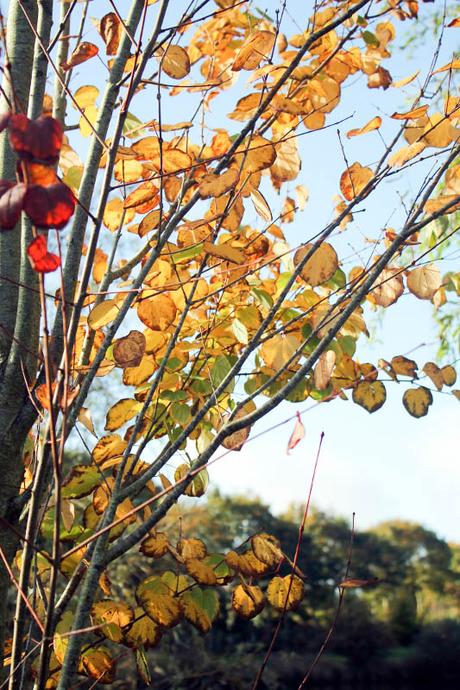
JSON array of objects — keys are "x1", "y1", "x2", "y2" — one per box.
[{"x1": 0, "y1": 0, "x2": 460, "y2": 689}]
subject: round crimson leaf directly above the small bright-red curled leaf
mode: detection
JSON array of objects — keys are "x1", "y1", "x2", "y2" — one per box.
[{"x1": 24, "y1": 182, "x2": 75, "y2": 230}]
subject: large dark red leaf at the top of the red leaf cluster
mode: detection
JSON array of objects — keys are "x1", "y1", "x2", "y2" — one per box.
[{"x1": 9, "y1": 114, "x2": 63, "y2": 163}]
